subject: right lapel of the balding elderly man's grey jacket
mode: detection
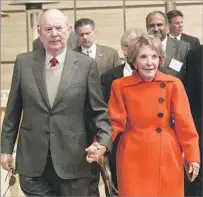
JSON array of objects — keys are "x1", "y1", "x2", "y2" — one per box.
[{"x1": 52, "y1": 50, "x2": 78, "y2": 108}]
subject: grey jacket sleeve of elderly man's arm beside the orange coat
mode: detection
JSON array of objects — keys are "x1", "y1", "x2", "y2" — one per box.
[{"x1": 88, "y1": 60, "x2": 112, "y2": 150}]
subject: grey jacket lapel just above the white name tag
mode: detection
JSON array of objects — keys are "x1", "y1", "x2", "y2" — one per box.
[{"x1": 165, "y1": 37, "x2": 176, "y2": 67}]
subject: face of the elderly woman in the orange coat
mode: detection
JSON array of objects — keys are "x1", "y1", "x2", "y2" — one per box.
[{"x1": 134, "y1": 45, "x2": 159, "y2": 81}]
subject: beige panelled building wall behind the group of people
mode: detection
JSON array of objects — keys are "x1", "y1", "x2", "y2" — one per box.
[{"x1": 1, "y1": 0, "x2": 203, "y2": 89}]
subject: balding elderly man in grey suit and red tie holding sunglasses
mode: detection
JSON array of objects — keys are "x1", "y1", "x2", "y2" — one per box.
[{"x1": 1, "y1": 9, "x2": 112, "y2": 196}]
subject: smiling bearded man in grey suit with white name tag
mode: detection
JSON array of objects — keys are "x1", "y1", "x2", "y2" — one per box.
[{"x1": 146, "y1": 11, "x2": 190, "y2": 80}]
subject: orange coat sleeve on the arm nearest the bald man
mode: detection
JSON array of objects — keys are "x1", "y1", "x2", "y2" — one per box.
[{"x1": 108, "y1": 79, "x2": 127, "y2": 141}]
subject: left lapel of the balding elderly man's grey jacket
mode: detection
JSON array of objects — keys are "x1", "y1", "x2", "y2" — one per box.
[{"x1": 32, "y1": 49, "x2": 51, "y2": 108}]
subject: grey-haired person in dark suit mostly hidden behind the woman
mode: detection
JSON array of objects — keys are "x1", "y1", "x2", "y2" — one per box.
[{"x1": 101, "y1": 29, "x2": 141, "y2": 195}]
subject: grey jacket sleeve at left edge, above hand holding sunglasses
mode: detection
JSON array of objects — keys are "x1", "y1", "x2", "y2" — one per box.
[{"x1": 1, "y1": 57, "x2": 22, "y2": 154}]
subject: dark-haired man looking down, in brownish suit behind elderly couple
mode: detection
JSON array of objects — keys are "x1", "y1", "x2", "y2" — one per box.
[{"x1": 74, "y1": 18, "x2": 121, "y2": 196}]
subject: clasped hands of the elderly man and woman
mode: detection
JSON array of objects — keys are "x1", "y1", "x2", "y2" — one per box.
[{"x1": 85, "y1": 142, "x2": 107, "y2": 163}]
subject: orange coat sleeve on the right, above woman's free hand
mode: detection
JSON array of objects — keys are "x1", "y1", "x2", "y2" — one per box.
[{"x1": 172, "y1": 79, "x2": 200, "y2": 163}]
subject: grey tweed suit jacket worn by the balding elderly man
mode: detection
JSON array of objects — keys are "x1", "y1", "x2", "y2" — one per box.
[{"x1": 1, "y1": 47, "x2": 112, "y2": 179}]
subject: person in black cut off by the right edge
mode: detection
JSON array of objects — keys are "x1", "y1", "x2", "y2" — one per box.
[{"x1": 184, "y1": 45, "x2": 203, "y2": 197}]
